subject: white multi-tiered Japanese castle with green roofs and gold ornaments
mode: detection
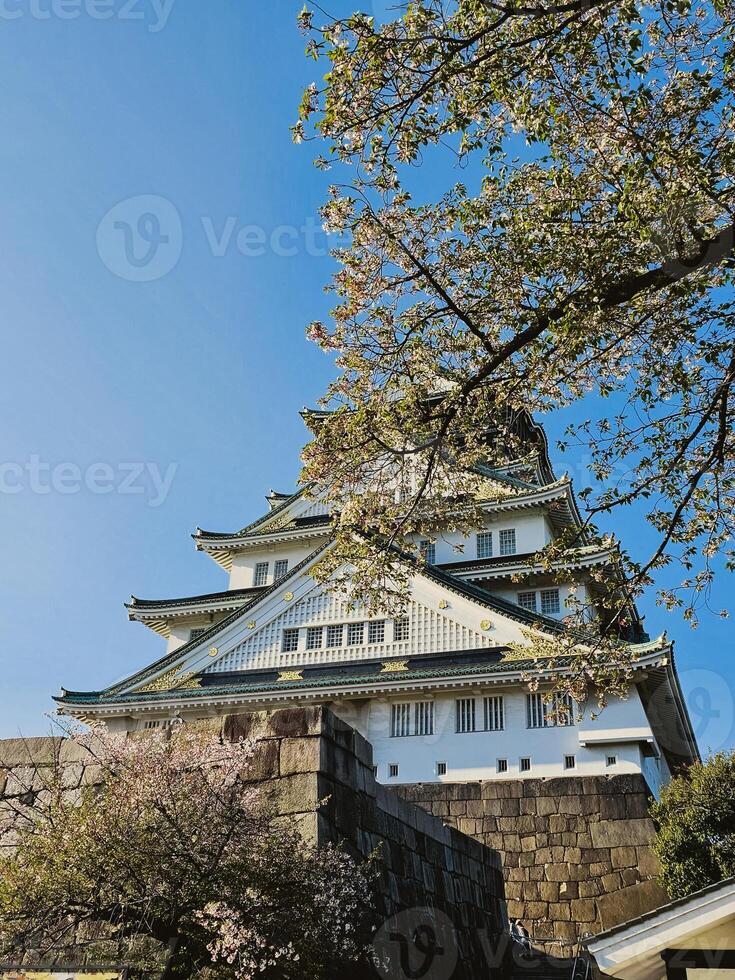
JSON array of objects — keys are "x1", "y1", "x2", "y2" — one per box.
[{"x1": 56, "y1": 412, "x2": 697, "y2": 793}]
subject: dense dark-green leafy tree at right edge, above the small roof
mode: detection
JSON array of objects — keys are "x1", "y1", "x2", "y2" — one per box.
[{"x1": 652, "y1": 752, "x2": 735, "y2": 898}]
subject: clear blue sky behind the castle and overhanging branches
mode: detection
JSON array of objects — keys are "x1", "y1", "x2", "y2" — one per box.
[{"x1": 0, "y1": 0, "x2": 735, "y2": 750}]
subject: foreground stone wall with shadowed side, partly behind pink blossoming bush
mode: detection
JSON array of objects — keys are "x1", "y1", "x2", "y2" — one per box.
[{"x1": 0, "y1": 708, "x2": 507, "y2": 980}]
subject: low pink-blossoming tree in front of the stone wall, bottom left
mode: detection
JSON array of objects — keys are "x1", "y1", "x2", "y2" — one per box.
[{"x1": 0, "y1": 726, "x2": 373, "y2": 980}]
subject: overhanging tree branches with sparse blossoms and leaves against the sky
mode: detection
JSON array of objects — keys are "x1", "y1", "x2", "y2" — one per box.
[{"x1": 294, "y1": 0, "x2": 735, "y2": 672}]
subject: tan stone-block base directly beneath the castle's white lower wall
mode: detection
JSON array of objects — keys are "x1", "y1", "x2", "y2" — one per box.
[{"x1": 396, "y1": 775, "x2": 668, "y2": 953}]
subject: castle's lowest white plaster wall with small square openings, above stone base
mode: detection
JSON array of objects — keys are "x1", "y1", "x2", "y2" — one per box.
[{"x1": 366, "y1": 688, "x2": 650, "y2": 783}]
